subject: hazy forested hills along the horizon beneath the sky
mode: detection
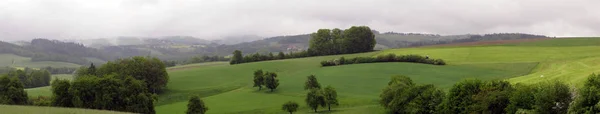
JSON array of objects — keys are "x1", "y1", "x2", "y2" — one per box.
[{"x1": 0, "y1": 30, "x2": 547, "y2": 65}]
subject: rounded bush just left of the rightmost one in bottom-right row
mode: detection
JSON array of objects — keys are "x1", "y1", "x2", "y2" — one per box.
[{"x1": 534, "y1": 82, "x2": 572, "y2": 114}]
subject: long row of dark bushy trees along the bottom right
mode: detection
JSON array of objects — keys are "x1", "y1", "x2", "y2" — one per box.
[{"x1": 380, "y1": 76, "x2": 580, "y2": 114}]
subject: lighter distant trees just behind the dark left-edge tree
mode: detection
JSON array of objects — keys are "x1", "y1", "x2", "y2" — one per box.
[{"x1": 6, "y1": 67, "x2": 51, "y2": 88}]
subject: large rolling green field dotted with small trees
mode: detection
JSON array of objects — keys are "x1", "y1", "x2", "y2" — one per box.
[{"x1": 15, "y1": 38, "x2": 600, "y2": 114}]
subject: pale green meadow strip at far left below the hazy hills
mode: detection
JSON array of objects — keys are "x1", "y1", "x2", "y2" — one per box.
[{"x1": 0, "y1": 54, "x2": 80, "y2": 68}]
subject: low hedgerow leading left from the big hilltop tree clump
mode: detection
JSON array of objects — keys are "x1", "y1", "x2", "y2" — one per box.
[{"x1": 229, "y1": 50, "x2": 310, "y2": 64}]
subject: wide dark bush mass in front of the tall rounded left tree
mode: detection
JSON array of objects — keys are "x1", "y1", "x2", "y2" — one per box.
[{"x1": 69, "y1": 75, "x2": 155, "y2": 114}]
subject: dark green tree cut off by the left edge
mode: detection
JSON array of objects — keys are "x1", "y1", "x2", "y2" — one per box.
[{"x1": 0, "y1": 76, "x2": 28, "y2": 105}]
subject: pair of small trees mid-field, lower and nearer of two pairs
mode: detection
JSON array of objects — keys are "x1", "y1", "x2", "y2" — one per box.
[{"x1": 304, "y1": 75, "x2": 339, "y2": 112}]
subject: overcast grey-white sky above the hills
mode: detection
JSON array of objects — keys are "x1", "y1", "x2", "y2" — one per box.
[{"x1": 0, "y1": 0, "x2": 600, "y2": 40}]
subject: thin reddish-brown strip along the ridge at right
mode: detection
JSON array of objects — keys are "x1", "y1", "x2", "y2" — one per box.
[{"x1": 420, "y1": 38, "x2": 551, "y2": 47}]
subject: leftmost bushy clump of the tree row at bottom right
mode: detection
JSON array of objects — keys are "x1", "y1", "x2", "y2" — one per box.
[{"x1": 380, "y1": 76, "x2": 444, "y2": 114}]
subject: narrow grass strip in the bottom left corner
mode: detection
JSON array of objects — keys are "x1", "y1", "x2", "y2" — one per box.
[{"x1": 0, "y1": 105, "x2": 130, "y2": 114}]
